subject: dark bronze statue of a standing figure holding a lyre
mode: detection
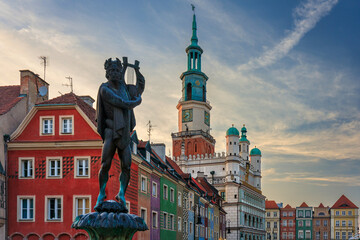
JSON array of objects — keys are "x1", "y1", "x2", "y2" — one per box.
[{"x1": 94, "y1": 57, "x2": 145, "y2": 212}]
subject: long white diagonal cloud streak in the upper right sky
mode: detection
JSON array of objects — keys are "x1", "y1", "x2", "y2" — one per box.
[{"x1": 239, "y1": 0, "x2": 338, "y2": 70}]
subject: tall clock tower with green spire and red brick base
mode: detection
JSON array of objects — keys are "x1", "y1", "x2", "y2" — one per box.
[{"x1": 171, "y1": 10, "x2": 215, "y2": 157}]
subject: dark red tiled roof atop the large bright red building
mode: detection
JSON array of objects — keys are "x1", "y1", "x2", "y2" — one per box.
[{"x1": 36, "y1": 93, "x2": 97, "y2": 126}]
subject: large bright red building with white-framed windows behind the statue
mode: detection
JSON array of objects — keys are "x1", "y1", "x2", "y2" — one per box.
[{"x1": 8, "y1": 93, "x2": 138, "y2": 239}]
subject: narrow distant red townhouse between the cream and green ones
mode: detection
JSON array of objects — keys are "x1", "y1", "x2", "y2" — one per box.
[{"x1": 280, "y1": 204, "x2": 296, "y2": 240}]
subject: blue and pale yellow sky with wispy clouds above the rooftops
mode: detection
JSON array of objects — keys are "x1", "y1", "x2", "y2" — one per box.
[{"x1": 0, "y1": 0, "x2": 360, "y2": 213}]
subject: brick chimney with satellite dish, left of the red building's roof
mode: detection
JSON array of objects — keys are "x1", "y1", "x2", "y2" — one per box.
[{"x1": 20, "y1": 70, "x2": 49, "y2": 112}]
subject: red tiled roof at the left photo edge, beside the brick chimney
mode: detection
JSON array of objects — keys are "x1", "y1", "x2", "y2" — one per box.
[{"x1": 0, "y1": 86, "x2": 23, "y2": 115}]
